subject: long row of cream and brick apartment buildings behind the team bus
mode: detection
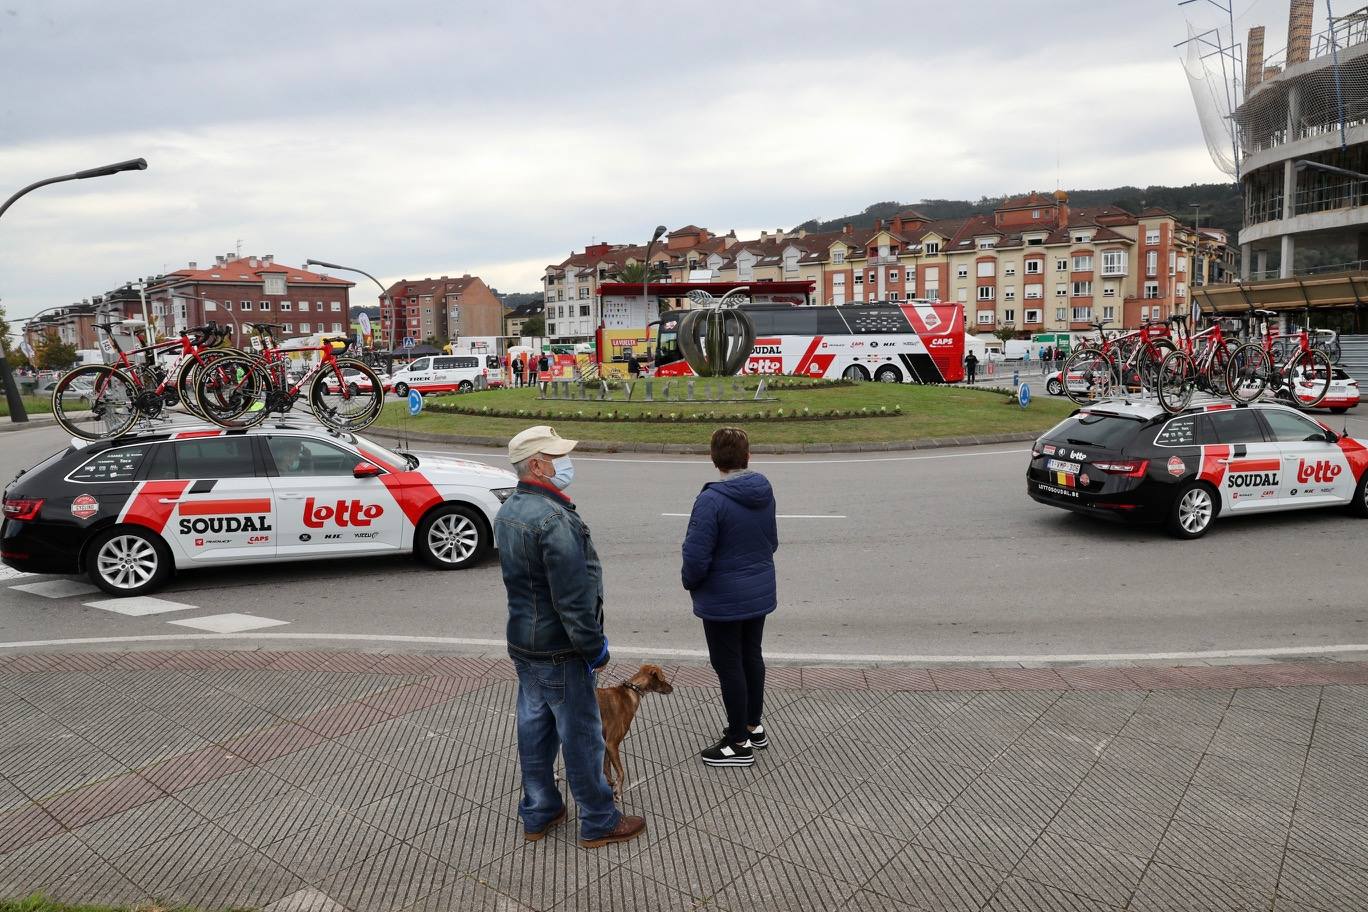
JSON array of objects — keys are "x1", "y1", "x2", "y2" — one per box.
[{"x1": 544, "y1": 191, "x2": 1233, "y2": 335}]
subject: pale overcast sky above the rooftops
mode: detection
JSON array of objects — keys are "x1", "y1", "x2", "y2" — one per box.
[{"x1": 0, "y1": 0, "x2": 1302, "y2": 324}]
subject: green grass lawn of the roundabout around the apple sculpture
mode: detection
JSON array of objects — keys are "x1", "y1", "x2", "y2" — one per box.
[{"x1": 376, "y1": 383, "x2": 1074, "y2": 444}]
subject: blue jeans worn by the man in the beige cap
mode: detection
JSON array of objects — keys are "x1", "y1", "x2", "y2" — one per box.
[{"x1": 513, "y1": 656, "x2": 621, "y2": 840}]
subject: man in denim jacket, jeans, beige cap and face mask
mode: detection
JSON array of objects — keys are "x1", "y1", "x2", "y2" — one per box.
[{"x1": 494, "y1": 425, "x2": 646, "y2": 848}]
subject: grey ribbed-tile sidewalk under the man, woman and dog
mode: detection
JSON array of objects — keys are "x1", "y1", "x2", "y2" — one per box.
[{"x1": 0, "y1": 652, "x2": 1368, "y2": 912}]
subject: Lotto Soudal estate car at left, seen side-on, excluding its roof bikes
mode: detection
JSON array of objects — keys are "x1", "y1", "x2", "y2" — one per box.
[{"x1": 0, "y1": 427, "x2": 517, "y2": 596}]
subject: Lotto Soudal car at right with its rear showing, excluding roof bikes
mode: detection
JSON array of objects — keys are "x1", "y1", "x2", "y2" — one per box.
[{"x1": 1026, "y1": 402, "x2": 1368, "y2": 539}]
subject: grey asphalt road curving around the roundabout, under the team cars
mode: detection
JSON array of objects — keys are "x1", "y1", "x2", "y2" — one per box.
[{"x1": 0, "y1": 413, "x2": 1368, "y2": 656}]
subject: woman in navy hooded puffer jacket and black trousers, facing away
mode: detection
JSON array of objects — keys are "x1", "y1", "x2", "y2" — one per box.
[{"x1": 681, "y1": 428, "x2": 778, "y2": 766}]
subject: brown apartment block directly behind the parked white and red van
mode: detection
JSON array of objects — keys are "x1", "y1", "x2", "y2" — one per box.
[{"x1": 376, "y1": 273, "x2": 503, "y2": 346}]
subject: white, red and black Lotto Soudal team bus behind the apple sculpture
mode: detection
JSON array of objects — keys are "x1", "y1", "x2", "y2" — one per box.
[{"x1": 648, "y1": 301, "x2": 964, "y2": 383}]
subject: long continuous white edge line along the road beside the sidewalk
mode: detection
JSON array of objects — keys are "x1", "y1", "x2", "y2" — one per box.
[{"x1": 0, "y1": 631, "x2": 1368, "y2": 665}]
